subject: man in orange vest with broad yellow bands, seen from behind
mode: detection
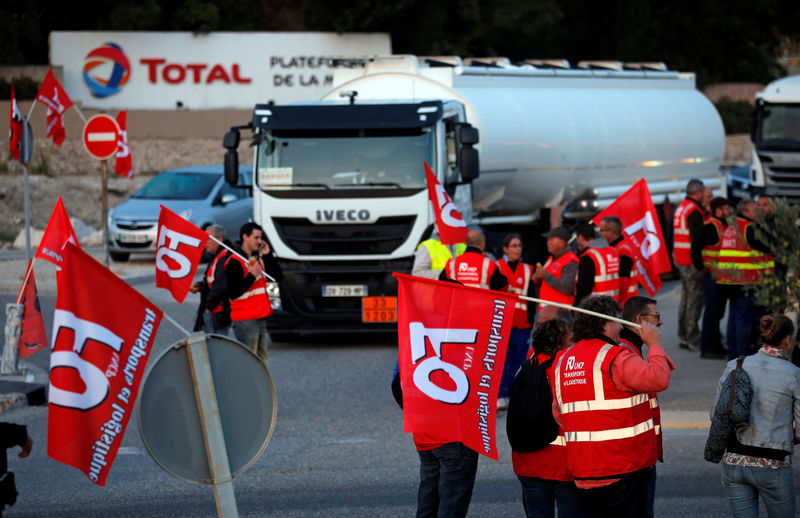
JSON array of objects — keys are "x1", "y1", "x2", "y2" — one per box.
[{"x1": 717, "y1": 198, "x2": 775, "y2": 360}]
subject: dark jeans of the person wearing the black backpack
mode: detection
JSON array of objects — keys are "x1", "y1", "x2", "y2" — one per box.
[{"x1": 517, "y1": 477, "x2": 583, "y2": 518}]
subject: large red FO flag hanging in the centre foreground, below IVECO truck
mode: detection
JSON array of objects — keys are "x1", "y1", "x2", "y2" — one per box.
[{"x1": 394, "y1": 273, "x2": 517, "y2": 460}]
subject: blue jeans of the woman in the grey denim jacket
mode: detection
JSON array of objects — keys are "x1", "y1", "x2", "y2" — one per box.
[{"x1": 722, "y1": 464, "x2": 795, "y2": 518}]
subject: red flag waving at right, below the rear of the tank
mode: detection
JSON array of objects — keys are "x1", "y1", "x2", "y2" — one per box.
[{"x1": 593, "y1": 178, "x2": 672, "y2": 297}]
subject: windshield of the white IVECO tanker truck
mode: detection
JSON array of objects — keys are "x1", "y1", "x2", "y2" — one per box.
[{"x1": 257, "y1": 127, "x2": 434, "y2": 190}]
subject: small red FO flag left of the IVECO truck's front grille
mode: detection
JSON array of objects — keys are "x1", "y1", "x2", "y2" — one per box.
[{"x1": 156, "y1": 205, "x2": 208, "y2": 304}]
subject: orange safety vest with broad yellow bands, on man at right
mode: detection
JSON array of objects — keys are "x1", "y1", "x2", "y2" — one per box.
[{"x1": 717, "y1": 217, "x2": 775, "y2": 285}]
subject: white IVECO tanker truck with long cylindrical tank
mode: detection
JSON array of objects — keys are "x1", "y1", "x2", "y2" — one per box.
[{"x1": 219, "y1": 56, "x2": 725, "y2": 340}]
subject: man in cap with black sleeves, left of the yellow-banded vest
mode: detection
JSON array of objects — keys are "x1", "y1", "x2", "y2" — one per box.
[{"x1": 691, "y1": 198, "x2": 732, "y2": 359}]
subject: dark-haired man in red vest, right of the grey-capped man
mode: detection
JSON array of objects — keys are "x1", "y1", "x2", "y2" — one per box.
[{"x1": 573, "y1": 223, "x2": 619, "y2": 306}]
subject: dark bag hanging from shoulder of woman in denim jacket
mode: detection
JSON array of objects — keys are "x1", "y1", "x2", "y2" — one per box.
[{"x1": 703, "y1": 356, "x2": 753, "y2": 463}]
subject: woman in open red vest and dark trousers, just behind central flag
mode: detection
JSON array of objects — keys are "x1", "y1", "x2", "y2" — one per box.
[{"x1": 497, "y1": 234, "x2": 536, "y2": 410}]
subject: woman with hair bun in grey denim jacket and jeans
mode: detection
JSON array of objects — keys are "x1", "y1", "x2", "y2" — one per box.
[{"x1": 711, "y1": 315, "x2": 800, "y2": 518}]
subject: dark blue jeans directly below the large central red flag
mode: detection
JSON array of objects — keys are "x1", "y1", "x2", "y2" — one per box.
[{"x1": 417, "y1": 442, "x2": 478, "y2": 518}]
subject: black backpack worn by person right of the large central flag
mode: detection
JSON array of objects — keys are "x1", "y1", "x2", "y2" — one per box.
[{"x1": 506, "y1": 354, "x2": 558, "y2": 453}]
